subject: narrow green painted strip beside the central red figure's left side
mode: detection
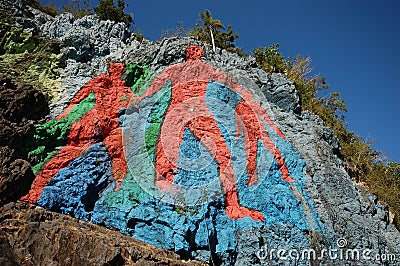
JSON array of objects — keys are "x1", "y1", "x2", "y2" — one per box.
[{"x1": 144, "y1": 80, "x2": 172, "y2": 155}]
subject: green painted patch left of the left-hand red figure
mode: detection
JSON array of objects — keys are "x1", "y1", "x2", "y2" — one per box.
[{"x1": 25, "y1": 92, "x2": 96, "y2": 174}]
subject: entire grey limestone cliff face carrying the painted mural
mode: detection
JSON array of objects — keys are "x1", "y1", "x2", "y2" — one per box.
[{"x1": 0, "y1": 1, "x2": 400, "y2": 265}]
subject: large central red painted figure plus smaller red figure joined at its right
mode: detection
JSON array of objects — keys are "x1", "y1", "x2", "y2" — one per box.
[{"x1": 131, "y1": 45, "x2": 294, "y2": 221}]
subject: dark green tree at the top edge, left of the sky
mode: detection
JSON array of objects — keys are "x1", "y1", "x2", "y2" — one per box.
[{"x1": 94, "y1": 0, "x2": 134, "y2": 26}]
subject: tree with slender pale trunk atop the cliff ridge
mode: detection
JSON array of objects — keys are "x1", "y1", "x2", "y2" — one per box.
[{"x1": 189, "y1": 9, "x2": 245, "y2": 56}]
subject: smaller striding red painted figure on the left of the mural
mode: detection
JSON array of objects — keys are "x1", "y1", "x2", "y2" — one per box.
[{"x1": 22, "y1": 63, "x2": 132, "y2": 203}]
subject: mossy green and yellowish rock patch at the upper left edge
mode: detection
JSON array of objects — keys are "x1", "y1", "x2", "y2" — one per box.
[{"x1": 0, "y1": 9, "x2": 61, "y2": 100}]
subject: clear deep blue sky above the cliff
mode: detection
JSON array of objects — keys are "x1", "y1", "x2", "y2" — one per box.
[{"x1": 42, "y1": 0, "x2": 400, "y2": 162}]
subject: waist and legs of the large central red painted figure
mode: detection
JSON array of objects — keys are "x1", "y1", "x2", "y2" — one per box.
[{"x1": 155, "y1": 81, "x2": 264, "y2": 221}]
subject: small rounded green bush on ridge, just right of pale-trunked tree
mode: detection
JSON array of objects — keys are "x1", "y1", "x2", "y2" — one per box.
[{"x1": 254, "y1": 43, "x2": 286, "y2": 73}]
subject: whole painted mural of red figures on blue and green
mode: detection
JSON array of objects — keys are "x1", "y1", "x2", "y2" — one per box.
[{"x1": 22, "y1": 45, "x2": 324, "y2": 261}]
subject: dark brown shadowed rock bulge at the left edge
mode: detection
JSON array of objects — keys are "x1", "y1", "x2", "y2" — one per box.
[{"x1": 0, "y1": 75, "x2": 48, "y2": 205}]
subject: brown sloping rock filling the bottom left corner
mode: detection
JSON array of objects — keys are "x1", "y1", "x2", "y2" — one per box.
[{"x1": 0, "y1": 203, "x2": 202, "y2": 266}]
